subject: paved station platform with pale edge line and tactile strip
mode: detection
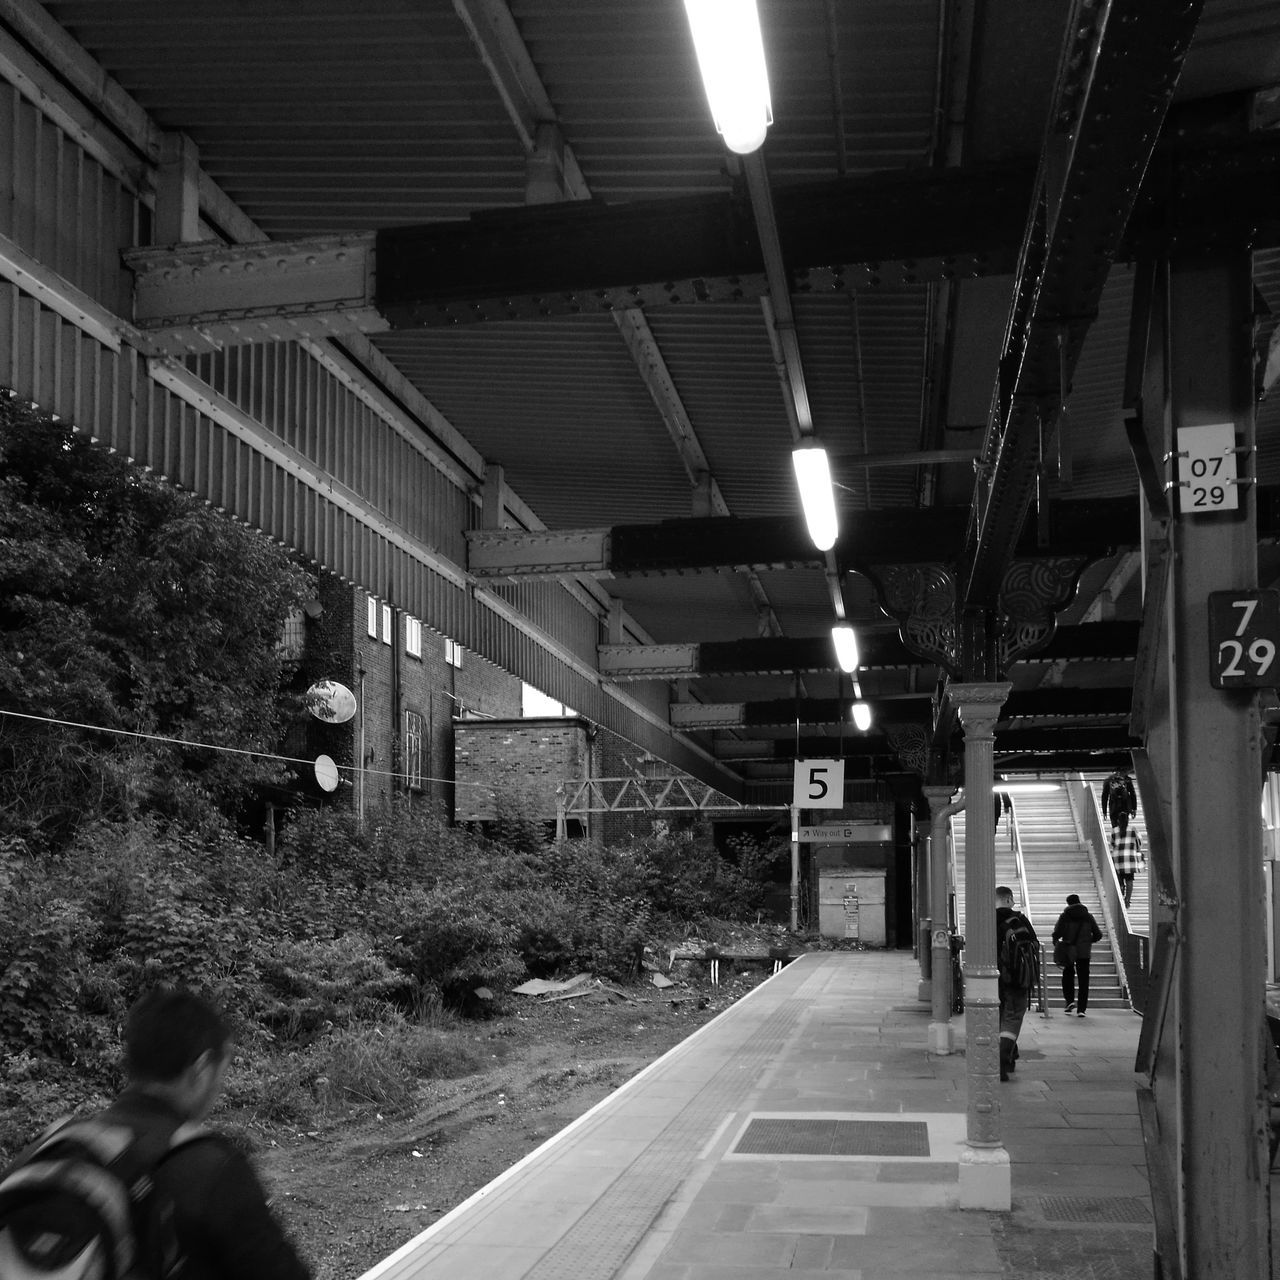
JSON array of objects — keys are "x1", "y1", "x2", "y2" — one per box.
[{"x1": 364, "y1": 951, "x2": 1153, "y2": 1280}]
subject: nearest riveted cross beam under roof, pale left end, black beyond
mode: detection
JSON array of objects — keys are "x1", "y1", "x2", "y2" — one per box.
[{"x1": 124, "y1": 133, "x2": 1280, "y2": 345}]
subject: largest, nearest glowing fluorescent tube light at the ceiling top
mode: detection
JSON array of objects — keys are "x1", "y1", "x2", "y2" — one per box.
[{"x1": 685, "y1": 0, "x2": 773, "y2": 156}]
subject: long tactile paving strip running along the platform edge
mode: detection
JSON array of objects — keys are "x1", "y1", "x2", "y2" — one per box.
[{"x1": 526, "y1": 970, "x2": 827, "y2": 1280}]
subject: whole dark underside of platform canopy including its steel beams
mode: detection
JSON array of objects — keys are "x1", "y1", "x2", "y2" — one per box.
[{"x1": 12, "y1": 0, "x2": 1280, "y2": 787}]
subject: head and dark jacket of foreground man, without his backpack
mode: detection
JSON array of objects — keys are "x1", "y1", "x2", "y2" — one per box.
[{"x1": 89, "y1": 987, "x2": 311, "y2": 1280}]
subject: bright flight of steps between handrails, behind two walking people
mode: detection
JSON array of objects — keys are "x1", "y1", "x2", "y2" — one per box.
[{"x1": 1014, "y1": 790, "x2": 1129, "y2": 1009}]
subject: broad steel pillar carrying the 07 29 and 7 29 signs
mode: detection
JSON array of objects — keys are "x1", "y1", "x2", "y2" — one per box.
[{"x1": 1172, "y1": 251, "x2": 1271, "y2": 1280}]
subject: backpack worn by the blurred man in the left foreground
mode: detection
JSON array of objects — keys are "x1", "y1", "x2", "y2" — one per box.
[{"x1": 0, "y1": 1117, "x2": 200, "y2": 1280}]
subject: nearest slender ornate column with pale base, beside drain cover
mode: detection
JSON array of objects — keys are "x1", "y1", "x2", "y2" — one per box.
[{"x1": 950, "y1": 684, "x2": 1012, "y2": 1210}]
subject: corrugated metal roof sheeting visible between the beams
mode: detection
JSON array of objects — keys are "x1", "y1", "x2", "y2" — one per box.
[{"x1": 20, "y1": 0, "x2": 1280, "y2": 768}]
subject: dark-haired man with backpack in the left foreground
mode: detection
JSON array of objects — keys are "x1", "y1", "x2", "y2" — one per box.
[{"x1": 0, "y1": 987, "x2": 311, "y2": 1280}]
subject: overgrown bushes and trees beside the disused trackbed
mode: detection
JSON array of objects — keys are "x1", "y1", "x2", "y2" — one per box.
[{"x1": 0, "y1": 398, "x2": 793, "y2": 1162}]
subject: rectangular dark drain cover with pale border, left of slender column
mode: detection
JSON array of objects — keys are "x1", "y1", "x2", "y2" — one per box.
[{"x1": 726, "y1": 1111, "x2": 965, "y2": 1161}]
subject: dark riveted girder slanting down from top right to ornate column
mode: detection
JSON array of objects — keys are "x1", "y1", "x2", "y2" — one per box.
[{"x1": 964, "y1": 0, "x2": 1201, "y2": 611}]
